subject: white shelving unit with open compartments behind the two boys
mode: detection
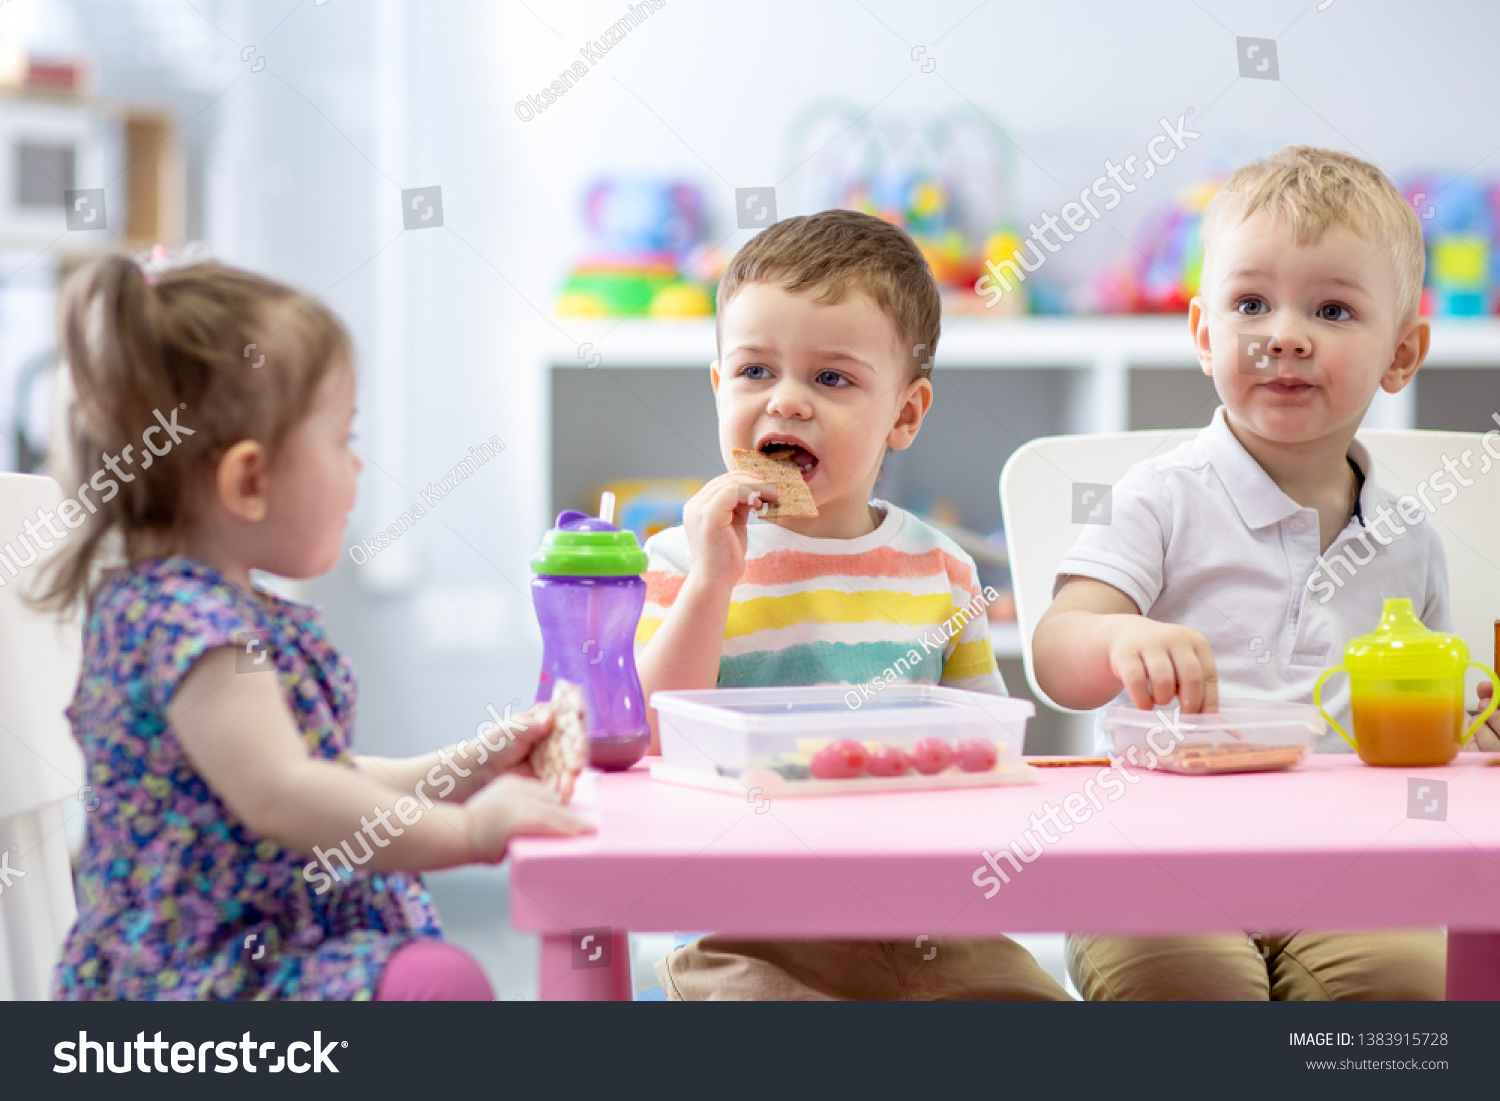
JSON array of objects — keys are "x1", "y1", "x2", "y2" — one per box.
[{"x1": 536, "y1": 317, "x2": 1500, "y2": 752}]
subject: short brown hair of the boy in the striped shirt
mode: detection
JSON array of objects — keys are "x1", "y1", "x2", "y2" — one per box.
[{"x1": 719, "y1": 210, "x2": 942, "y2": 380}]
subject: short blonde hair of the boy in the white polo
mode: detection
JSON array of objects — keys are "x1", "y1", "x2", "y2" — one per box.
[{"x1": 1199, "y1": 146, "x2": 1427, "y2": 321}]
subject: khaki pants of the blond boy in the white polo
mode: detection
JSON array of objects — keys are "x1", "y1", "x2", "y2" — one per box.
[{"x1": 1068, "y1": 930, "x2": 1448, "y2": 1002}]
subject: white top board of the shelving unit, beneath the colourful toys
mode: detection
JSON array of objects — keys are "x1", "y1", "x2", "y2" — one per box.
[{"x1": 548, "y1": 315, "x2": 1500, "y2": 369}]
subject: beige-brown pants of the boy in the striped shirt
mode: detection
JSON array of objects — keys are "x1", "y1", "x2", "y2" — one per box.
[{"x1": 656, "y1": 936, "x2": 1071, "y2": 1002}]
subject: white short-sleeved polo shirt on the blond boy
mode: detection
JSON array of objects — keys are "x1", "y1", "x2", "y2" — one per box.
[{"x1": 1053, "y1": 407, "x2": 1452, "y2": 753}]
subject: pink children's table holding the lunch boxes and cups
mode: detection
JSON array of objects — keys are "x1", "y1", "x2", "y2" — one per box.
[{"x1": 510, "y1": 753, "x2": 1500, "y2": 999}]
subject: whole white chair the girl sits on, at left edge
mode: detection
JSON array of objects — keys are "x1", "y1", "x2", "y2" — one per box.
[{"x1": 0, "y1": 474, "x2": 90, "y2": 1001}]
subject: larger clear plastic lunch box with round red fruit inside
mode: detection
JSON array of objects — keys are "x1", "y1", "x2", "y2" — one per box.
[{"x1": 651, "y1": 684, "x2": 1037, "y2": 779}]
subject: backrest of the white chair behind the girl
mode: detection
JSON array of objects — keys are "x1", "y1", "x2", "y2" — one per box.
[{"x1": 0, "y1": 474, "x2": 84, "y2": 819}]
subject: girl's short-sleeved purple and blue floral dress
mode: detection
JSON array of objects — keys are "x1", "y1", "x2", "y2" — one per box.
[{"x1": 54, "y1": 558, "x2": 443, "y2": 1001}]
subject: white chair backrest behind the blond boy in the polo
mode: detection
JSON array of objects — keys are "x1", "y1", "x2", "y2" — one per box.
[{"x1": 1001, "y1": 429, "x2": 1500, "y2": 720}]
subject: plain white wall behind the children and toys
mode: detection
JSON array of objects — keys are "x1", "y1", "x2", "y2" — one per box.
[{"x1": 79, "y1": 0, "x2": 1500, "y2": 752}]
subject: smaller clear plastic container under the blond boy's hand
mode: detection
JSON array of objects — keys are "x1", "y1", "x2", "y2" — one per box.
[{"x1": 1101, "y1": 699, "x2": 1323, "y2": 776}]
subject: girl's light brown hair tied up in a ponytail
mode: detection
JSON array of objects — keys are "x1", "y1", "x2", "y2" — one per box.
[{"x1": 38, "y1": 257, "x2": 351, "y2": 611}]
